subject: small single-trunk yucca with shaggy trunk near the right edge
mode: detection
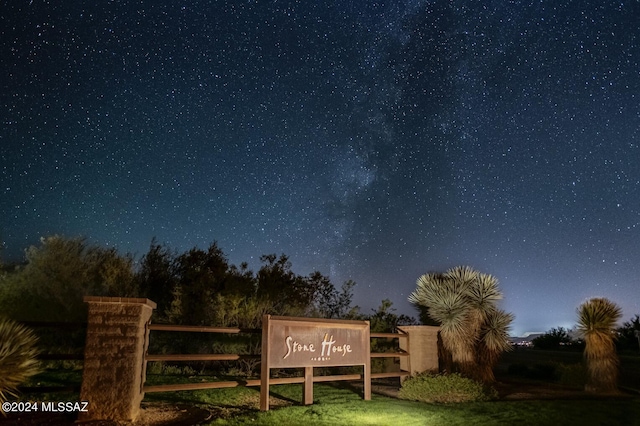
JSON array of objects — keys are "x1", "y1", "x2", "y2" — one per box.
[{"x1": 578, "y1": 298, "x2": 622, "y2": 392}]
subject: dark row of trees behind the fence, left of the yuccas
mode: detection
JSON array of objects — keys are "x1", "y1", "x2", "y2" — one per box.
[{"x1": 0, "y1": 236, "x2": 414, "y2": 331}]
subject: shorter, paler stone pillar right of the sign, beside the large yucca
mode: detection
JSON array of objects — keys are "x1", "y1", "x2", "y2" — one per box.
[{"x1": 398, "y1": 325, "x2": 440, "y2": 375}]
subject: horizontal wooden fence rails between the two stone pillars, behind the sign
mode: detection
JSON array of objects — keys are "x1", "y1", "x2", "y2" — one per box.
[{"x1": 143, "y1": 324, "x2": 411, "y2": 393}]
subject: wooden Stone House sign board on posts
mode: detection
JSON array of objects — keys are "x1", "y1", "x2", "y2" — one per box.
[{"x1": 260, "y1": 315, "x2": 371, "y2": 411}]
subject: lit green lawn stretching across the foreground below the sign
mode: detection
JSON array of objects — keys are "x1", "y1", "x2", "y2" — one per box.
[{"x1": 145, "y1": 384, "x2": 640, "y2": 426}]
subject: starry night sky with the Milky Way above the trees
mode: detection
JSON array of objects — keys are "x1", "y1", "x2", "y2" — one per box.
[{"x1": 0, "y1": 0, "x2": 640, "y2": 335}]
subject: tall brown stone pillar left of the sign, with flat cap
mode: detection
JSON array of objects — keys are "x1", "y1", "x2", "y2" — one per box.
[{"x1": 78, "y1": 296, "x2": 156, "y2": 422}]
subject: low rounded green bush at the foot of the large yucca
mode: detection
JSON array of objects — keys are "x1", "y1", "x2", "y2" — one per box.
[{"x1": 398, "y1": 373, "x2": 497, "y2": 404}]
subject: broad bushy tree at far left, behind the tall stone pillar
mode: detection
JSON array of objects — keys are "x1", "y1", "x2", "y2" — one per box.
[{"x1": 0, "y1": 235, "x2": 138, "y2": 321}]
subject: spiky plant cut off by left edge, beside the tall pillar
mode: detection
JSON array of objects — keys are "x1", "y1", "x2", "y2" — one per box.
[{"x1": 0, "y1": 319, "x2": 39, "y2": 412}]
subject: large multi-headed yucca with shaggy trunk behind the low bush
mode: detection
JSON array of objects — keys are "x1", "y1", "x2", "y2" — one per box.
[{"x1": 409, "y1": 266, "x2": 513, "y2": 382}]
